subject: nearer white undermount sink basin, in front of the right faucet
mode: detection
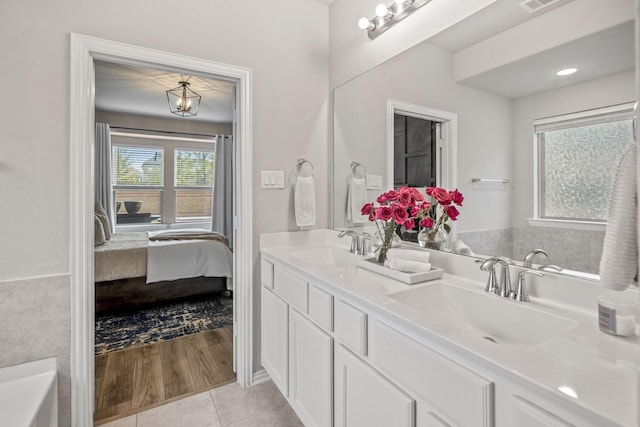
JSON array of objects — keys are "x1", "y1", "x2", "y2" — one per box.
[{"x1": 387, "y1": 281, "x2": 578, "y2": 345}]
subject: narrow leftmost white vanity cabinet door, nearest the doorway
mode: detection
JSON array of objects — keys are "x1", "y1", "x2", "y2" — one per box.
[{"x1": 261, "y1": 287, "x2": 289, "y2": 396}]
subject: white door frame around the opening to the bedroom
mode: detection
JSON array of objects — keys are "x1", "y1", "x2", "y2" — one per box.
[{"x1": 69, "y1": 33, "x2": 253, "y2": 427}]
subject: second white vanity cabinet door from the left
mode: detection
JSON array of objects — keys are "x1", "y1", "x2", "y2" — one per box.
[{"x1": 289, "y1": 309, "x2": 333, "y2": 427}]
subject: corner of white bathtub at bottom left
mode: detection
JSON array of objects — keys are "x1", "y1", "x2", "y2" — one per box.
[{"x1": 0, "y1": 358, "x2": 58, "y2": 427}]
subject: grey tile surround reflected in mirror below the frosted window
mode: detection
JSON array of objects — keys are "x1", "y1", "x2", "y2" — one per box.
[{"x1": 458, "y1": 226, "x2": 604, "y2": 274}]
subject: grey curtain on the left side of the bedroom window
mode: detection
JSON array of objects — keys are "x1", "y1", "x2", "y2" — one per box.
[{"x1": 95, "y1": 123, "x2": 115, "y2": 232}]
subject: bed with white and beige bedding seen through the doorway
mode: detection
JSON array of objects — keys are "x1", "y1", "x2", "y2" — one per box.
[{"x1": 94, "y1": 229, "x2": 233, "y2": 313}]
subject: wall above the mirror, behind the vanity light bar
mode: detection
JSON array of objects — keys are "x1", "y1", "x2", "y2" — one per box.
[{"x1": 329, "y1": 0, "x2": 497, "y2": 88}]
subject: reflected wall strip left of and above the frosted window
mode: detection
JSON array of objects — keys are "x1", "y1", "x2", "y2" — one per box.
[{"x1": 512, "y1": 71, "x2": 636, "y2": 227}]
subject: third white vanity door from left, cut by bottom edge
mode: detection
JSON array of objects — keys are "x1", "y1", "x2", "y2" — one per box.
[{"x1": 335, "y1": 345, "x2": 415, "y2": 427}]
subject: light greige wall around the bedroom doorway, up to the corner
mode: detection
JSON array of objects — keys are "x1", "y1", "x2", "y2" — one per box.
[{"x1": 0, "y1": 0, "x2": 329, "y2": 426}]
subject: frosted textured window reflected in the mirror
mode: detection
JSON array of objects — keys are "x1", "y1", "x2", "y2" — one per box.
[{"x1": 535, "y1": 104, "x2": 633, "y2": 223}]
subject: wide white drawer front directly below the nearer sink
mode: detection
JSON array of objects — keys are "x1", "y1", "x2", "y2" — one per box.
[{"x1": 369, "y1": 320, "x2": 494, "y2": 427}]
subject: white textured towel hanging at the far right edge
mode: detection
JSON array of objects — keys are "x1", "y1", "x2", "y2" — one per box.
[{"x1": 600, "y1": 144, "x2": 638, "y2": 291}]
